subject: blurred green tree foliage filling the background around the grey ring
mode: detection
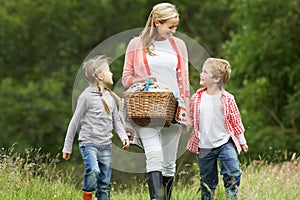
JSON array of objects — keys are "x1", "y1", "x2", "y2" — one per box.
[{"x1": 0, "y1": 0, "x2": 300, "y2": 161}]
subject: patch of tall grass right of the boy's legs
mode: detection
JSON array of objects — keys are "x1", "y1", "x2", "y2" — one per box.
[{"x1": 240, "y1": 159, "x2": 300, "y2": 200}]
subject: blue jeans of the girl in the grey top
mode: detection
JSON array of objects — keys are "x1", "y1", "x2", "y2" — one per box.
[{"x1": 79, "y1": 142, "x2": 112, "y2": 200}]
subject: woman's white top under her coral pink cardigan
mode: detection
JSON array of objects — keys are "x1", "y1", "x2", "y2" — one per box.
[{"x1": 146, "y1": 40, "x2": 179, "y2": 94}]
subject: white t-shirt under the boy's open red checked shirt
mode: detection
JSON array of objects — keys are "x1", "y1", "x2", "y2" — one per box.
[{"x1": 198, "y1": 92, "x2": 230, "y2": 149}]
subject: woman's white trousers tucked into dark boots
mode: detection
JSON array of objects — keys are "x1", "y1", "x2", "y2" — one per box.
[{"x1": 138, "y1": 124, "x2": 182, "y2": 176}]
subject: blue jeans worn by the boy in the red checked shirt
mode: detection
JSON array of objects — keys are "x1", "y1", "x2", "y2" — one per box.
[{"x1": 198, "y1": 140, "x2": 242, "y2": 199}]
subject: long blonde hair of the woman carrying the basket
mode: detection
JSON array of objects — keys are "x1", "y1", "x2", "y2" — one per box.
[{"x1": 140, "y1": 3, "x2": 179, "y2": 55}]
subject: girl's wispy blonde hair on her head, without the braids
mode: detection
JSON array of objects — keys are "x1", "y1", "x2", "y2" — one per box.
[{"x1": 82, "y1": 55, "x2": 109, "y2": 84}]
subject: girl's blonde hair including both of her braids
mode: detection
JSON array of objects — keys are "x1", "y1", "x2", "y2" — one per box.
[{"x1": 82, "y1": 55, "x2": 121, "y2": 115}]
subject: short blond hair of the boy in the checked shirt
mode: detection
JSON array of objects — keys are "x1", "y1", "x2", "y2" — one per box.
[{"x1": 204, "y1": 58, "x2": 231, "y2": 85}]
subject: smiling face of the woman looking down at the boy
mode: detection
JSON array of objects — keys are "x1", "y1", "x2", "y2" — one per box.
[{"x1": 155, "y1": 17, "x2": 179, "y2": 40}]
